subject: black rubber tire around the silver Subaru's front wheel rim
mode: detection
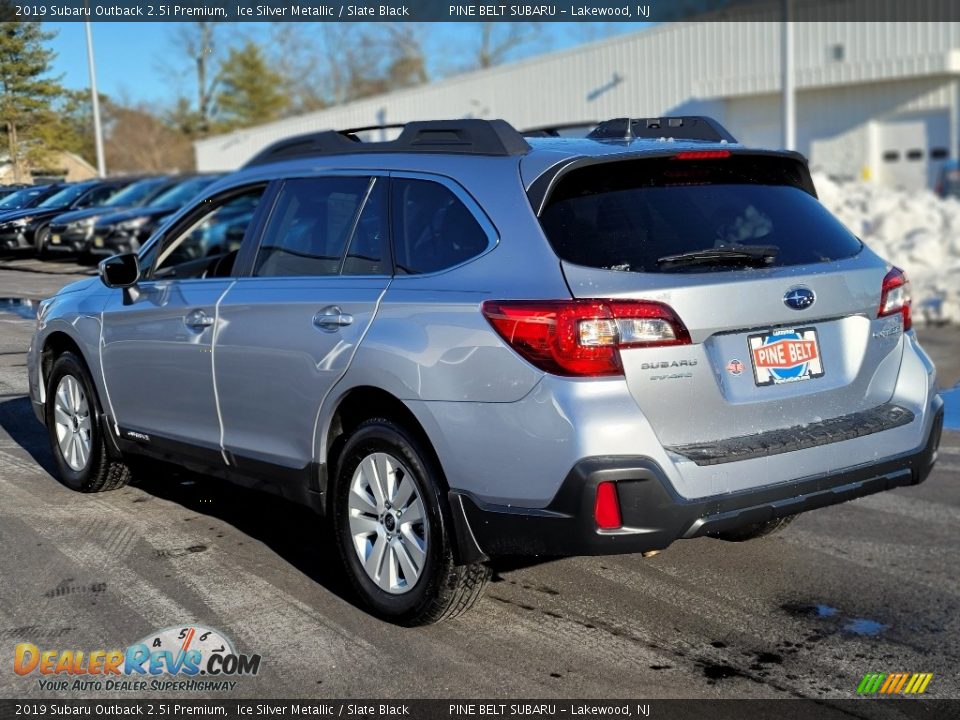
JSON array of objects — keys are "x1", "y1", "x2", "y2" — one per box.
[{"x1": 46, "y1": 352, "x2": 131, "y2": 493}]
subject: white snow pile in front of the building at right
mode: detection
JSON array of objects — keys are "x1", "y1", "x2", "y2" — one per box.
[{"x1": 813, "y1": 173, "x2": 960, "y2": 323}]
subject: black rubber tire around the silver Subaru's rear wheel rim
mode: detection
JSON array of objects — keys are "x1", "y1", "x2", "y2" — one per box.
[{"x1": 333, "y1": 418, "x2": 490, "y2": 626}]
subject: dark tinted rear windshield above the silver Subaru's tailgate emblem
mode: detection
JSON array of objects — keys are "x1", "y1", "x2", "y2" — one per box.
[{"x1": 541, "y1": 158, "x2": 861, "y2": 272}]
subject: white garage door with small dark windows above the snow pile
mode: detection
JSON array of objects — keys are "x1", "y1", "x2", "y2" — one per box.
[{"x1": 876, "y1": 111, "x2": 950, "y2": 190}]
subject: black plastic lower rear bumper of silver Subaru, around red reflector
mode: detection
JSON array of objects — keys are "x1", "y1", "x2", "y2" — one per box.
[{"x1": 450, "y1": 398, "x2": 943, "y2": 560}]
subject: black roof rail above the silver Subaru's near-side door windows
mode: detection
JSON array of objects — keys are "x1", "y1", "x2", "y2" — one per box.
[{"x1": 244, "y1": 119, "x2": 530, "y2": 167}]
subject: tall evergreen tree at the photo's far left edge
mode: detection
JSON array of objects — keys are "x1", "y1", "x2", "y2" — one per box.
[{"x1": 0, "y1": 22, "x2": 63, "y2": 181}]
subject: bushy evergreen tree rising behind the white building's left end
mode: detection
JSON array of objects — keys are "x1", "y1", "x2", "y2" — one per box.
[{"x1": 217, "y1": 40, "x2": 289, "y2": 129}]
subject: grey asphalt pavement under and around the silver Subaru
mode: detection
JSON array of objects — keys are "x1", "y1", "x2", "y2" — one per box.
[{"x1": 0, "y1": 260, "x2": 960, "y2": 700}]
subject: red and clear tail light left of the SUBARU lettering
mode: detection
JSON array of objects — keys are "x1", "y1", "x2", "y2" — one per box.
[{"x1": 482, "y1": 300, "x2": 690, "y2": 377}]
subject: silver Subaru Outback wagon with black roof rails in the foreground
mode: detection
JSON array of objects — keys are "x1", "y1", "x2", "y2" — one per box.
[{"x1": 29, "y1": 117, "x2": 943, "y2": 624}]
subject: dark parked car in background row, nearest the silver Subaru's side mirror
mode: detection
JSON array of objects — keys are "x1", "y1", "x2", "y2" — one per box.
[{"x1": 84, "y1": 175, "x2": 221, "y2": 259}]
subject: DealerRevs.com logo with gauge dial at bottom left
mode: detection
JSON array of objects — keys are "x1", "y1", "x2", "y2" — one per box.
[{"x1": 13, "y1": 626, "x2": 261, "y2": 692}]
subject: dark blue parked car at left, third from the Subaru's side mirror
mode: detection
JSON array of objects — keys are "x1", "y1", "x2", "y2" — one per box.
[{"x1": 0, "y1": 178, "x2": 137, "y2": 253}]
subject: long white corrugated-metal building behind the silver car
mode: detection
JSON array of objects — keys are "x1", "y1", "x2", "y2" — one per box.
[{"x1": 195, "y1": 9, "x2": 960, "y2": 188}]
